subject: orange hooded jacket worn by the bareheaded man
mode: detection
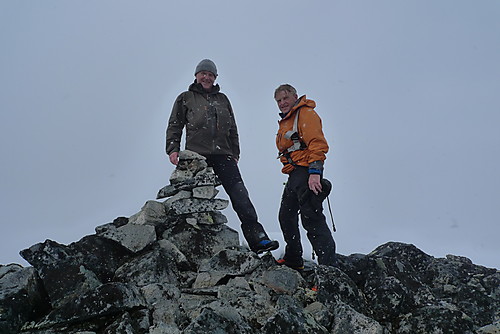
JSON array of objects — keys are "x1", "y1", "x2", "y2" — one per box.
[{"x1": 276, "y1": 95, "x2": 328, "y2": 174}]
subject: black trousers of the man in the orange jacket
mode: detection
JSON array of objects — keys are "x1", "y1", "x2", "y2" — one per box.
[{"x1": 279, "y1": 166, "x2": 336, "y2": 266}]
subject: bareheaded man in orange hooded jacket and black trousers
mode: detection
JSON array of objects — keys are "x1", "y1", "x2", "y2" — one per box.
[{"x1": 274, "y1": 84, "x2": 336, "y2": 270}]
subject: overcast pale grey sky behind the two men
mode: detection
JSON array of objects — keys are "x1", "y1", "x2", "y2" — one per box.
[{"x1": 0, "y1": 0, "x2": 500, "y2": 268}]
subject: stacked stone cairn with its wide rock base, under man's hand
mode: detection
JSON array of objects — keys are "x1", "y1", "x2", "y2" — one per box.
[{"x1": 91, "y1": 150, "x2": 239, "y2": 267}]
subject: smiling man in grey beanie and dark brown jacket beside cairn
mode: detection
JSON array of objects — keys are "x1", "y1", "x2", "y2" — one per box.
[{"x1": 166, "y1": 59, "x2": 279, "y2": 253}]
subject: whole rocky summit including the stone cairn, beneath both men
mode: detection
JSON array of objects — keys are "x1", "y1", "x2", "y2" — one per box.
[{"x1": 0, "y1": 151, "x2": 500, "y2": 334}]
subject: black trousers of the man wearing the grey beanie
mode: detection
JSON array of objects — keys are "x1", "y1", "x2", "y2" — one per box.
[{"x1": 205, "y1": 155, "x2": 269, "y2": 246}]
